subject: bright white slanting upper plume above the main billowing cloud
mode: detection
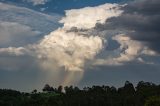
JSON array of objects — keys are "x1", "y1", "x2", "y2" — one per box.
[{"x1": 60, "y1": 3, "x2": 123, "y2": 29}]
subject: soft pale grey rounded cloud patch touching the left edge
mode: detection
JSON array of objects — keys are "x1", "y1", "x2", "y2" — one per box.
[{"x1": 0, "y1": 21, "x2": 40, "y2": 47}]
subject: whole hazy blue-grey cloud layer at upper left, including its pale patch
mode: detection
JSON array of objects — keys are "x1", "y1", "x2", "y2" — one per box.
[{"x1": 0, "y1": 2, "x2": 60, "y2": 48}]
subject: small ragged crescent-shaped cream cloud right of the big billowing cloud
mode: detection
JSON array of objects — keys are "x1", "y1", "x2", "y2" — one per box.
[{"x1": 113, "y1": 35, "x2": 157, "y2": 62}]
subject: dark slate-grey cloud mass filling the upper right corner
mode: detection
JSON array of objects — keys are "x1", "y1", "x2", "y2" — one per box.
[{"x1": 97, "y1": 0, "x2": 160, "y2": 52}]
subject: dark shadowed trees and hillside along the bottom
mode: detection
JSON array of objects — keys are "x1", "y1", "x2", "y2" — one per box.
[{"x1": 0, "y1": 81, "x2": 160, "y2": 106}]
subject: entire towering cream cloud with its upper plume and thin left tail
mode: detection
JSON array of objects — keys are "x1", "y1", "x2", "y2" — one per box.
[{"x1": 1, "y1": 4, "x2": 122, "y2": 71}]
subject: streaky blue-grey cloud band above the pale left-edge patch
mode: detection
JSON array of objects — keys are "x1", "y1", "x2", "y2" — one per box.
[{"x1": 0, "y1": 2, "x2": 61, "y2": 35}]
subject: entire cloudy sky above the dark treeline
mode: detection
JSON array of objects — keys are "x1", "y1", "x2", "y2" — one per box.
[{"x1": 0, "y1": 0, "x2": 160, "y2": 92}]
